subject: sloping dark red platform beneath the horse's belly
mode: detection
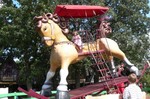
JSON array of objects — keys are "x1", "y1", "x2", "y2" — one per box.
[{"x1": 69, "y1": 77, "x2": 128, "y2": 99}]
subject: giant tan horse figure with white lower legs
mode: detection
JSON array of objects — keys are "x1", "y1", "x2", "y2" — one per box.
[{"x1": 34, "y1": 13, "x2": 138, "y2": 96}]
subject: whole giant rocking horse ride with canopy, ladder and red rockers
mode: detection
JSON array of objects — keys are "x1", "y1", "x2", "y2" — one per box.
[{"x1": 18, "y1": 5, "x2": 150, "y2": 99}]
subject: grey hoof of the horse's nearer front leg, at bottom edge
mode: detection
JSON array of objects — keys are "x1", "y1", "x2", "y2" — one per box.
[{"x1": 56, "y1": 90, "x2": 70, "y2": 99}]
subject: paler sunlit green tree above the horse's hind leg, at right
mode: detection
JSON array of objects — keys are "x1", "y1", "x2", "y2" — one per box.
[{"x1": 106, "y1": 0, "x2": 150, "y2": 64}]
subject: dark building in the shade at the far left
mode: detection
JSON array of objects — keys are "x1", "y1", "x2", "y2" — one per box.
[{"x1": 0, "y1": 56, "x2": 18, "y2": 92}]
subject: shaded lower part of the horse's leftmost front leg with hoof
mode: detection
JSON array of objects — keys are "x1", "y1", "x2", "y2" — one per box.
[{"x1": 41, "y1": 69, "x2": 55, "y2": 97}]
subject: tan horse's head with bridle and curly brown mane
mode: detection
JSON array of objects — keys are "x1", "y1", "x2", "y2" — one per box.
[{"x1": 34, "y1": 13, "x2": 68, "y2": 46}]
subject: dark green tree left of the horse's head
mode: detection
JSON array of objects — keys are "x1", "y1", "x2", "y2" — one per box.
[{"x1": 0, "y1": 0, "x2": 55, "y2": 88}]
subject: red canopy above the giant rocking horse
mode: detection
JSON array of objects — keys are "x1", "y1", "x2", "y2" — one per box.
[{"x1": 55, "y1": 5, "x2": 109, "y2": 18}]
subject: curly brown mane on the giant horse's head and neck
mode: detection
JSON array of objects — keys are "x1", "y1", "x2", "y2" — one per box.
[{"x1": 33, "y1": 13, "x2": 69, "y2": 34}]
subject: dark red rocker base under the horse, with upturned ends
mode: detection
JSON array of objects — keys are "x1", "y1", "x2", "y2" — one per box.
[{"x1": 18, "y1": 61, "x2": 150, "y2": 99}]
